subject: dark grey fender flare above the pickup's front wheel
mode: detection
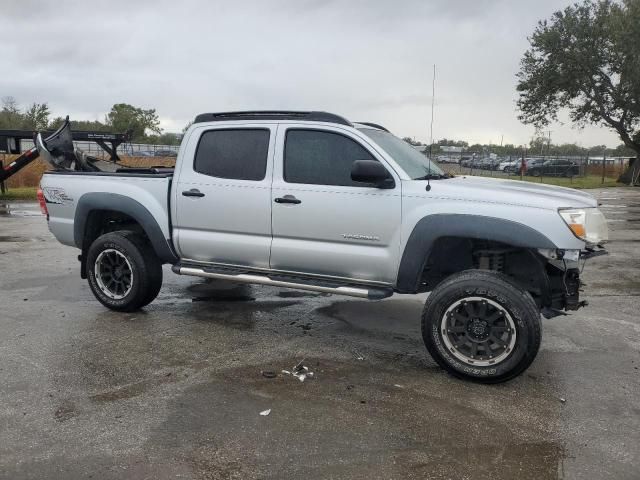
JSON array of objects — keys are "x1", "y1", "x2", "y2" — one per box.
[{"x1": 396, "y1": 214, "x2": 557, "y2": 293}]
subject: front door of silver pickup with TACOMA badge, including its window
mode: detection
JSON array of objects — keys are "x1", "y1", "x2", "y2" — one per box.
[{"x1": 271, "y1": 124, "x2": 401, "y2": 283}]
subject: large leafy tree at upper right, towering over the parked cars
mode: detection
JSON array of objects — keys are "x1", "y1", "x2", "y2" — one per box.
[{"x1": 517, "y1": 0, "x2": 640, "y2": 182}]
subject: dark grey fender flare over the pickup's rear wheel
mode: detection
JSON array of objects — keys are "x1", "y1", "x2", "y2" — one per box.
[{"x1": 73, "y1": 192, "x2": 178, "y2": 264}]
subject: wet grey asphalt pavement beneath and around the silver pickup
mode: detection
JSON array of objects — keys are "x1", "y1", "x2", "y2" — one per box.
[{"x1": 0, "y1": 188, "x2": 640, "y2": 479}]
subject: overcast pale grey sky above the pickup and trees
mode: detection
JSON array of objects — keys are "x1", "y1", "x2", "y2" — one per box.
[{"x1": 0, "y1": 0, "x2": 620, "y2": 146}]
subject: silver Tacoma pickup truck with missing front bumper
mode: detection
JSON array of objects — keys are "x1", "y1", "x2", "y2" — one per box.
[{"x1": 38, "y1": 111, "x2": 608, "y2": 383}]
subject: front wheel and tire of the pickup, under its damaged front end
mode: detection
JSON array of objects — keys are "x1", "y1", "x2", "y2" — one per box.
[{"x1": 422, "y1": 270, "x2": 542, "y2": 383}]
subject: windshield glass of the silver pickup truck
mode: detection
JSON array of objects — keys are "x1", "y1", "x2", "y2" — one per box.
[{"x1": 358, "y1": 128, "x2": 444, "y2": 180}]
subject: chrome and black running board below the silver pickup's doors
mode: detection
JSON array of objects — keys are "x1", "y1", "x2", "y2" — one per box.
[{"x1": 171, "y1": 263, "x2": 393, "y2": 300}]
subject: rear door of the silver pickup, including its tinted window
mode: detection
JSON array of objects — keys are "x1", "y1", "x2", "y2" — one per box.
[{"x1": 172, "y1": 123, "x2": 276, "y2": 268}]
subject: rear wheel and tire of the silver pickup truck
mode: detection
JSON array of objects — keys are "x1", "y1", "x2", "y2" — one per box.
[{"x1": 86, "y1": 230, "x2": 162, "y2": 312}]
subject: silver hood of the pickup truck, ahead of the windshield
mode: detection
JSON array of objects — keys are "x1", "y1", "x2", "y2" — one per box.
[{"x1": 403, "y1": 176, "x2": 598, "y2": 210}]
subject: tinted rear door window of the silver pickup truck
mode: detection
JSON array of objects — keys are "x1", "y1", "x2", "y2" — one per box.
[{"x1": 193, "y1": 128, "x2": 270, "y2": 180}]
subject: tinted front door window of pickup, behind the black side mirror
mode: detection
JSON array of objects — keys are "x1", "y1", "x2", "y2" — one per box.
[{"x1": 284, "y1": 129, "x2": 375, "y2": 187}]
